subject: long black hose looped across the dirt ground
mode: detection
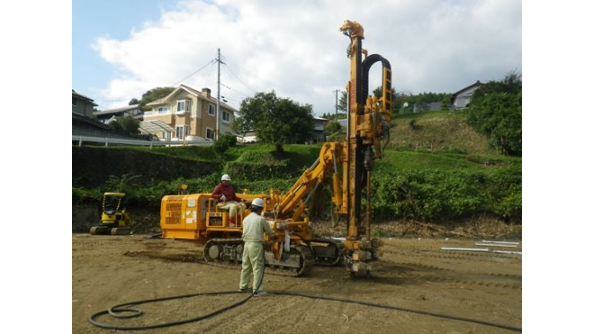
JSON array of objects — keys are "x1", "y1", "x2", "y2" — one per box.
[{"x1": 88, "y1": 241, "x2": 523, "y2": 332}]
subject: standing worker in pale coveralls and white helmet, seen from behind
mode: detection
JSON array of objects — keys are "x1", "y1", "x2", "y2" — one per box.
[{"x1": 240, "y1": 198, "x2": 275, "y2": 296}]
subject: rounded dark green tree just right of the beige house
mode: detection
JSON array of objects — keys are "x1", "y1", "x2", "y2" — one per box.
[{"x1": 235, "y1": 91, "x2": 314, "y2": 151}]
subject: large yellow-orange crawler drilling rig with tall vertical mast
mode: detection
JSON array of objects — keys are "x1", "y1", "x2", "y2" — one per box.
[{"x1": 160, "y1": 21, "x2": 392, "y2": 276}]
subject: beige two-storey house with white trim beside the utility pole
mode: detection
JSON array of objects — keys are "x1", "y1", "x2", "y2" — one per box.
[{"x1": 143, "y1": 85, "x2": 236, "y2": 140}]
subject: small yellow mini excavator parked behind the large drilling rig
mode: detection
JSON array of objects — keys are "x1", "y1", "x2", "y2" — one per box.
[{"x1": 89, "y1": 192, "x2": 134, "y2": 235}]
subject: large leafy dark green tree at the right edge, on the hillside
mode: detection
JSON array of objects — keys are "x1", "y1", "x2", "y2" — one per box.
[{"x1": 467, "y1": 71, "x2": 523, "y2": 156}]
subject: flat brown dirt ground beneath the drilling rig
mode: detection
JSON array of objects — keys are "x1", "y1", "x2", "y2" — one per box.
[{"x1": 72, "y1": 234, "x2": 522, "y2": 334}]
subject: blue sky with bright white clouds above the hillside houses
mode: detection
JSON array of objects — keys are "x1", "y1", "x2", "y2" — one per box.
[{"x1": 72, "y1": 0, "x2": 522, "y2": 115}]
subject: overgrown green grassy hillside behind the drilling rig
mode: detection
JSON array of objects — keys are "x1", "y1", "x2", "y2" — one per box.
[{"x1": 73, "y1": 112, "x2": 522, "y2": 224}]
